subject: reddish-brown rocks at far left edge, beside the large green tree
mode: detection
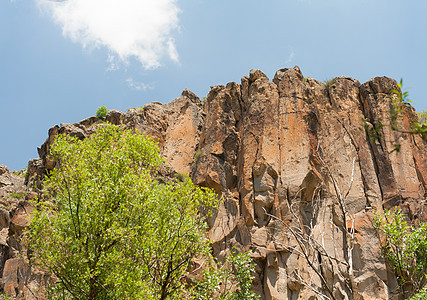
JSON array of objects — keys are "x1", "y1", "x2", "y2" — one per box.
[{"x1": 0, "y1": 165, "x2": 49, "y2": 300}]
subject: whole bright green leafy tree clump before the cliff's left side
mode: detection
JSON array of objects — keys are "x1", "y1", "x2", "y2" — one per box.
[{"x1": 28, "y1": 125, "x2": 216, "y2": 300}]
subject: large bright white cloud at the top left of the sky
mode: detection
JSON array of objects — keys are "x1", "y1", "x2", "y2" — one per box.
[{"x1": 37, "y1": 0, "x2": 180, "y2": 69}]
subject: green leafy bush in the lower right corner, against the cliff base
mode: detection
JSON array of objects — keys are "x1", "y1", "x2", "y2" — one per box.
[{"x1": 375, "y1": 210, "x2": 427, "y2": 298}]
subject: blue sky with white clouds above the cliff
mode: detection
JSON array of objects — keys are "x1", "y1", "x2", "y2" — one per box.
[{"x1": 0, "y1": 0, "x2": 427, "y2": 169}]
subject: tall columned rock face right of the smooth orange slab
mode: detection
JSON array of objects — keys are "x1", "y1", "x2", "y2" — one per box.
[{"x1": 192, "y1": 67, "x2": 427, "y2": 299}]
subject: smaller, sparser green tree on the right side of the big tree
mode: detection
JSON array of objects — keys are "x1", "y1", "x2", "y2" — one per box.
[{"x1": 126, "y1": 178, "x2": 215, "y2": 299}]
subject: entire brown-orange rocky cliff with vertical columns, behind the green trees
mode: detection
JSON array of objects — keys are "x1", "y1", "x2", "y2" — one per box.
[{"x1": 0, "y1": 67, "x2": 427, "y2": 299}]
